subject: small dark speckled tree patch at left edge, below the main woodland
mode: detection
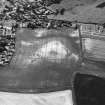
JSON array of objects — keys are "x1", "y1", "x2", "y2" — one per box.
[{"x1": 0, "y1": 35, "x2": 15, "y2": 66}]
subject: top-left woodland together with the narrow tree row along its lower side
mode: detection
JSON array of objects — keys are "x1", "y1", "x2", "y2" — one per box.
[{"x1": 0, "y1": 0, "x2": 74, "y2": 29}]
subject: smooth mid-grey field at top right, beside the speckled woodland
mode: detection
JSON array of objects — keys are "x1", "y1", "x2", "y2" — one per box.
[{"x1": 49, "y1": 0, "x2": 105, "y2": 23}]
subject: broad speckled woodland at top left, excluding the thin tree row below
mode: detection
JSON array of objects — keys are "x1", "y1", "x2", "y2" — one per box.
[{"x1": 0, "y1": 0, "x2": 58, "y2": 22}]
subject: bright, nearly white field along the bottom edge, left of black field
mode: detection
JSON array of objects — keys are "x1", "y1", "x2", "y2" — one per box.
[{"x1": 0, "y1": 90, "x2": 73, "y2": 105}]
